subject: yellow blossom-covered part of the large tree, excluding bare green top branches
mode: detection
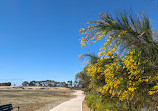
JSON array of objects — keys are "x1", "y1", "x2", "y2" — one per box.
[{"x1": 80, "y1": 11, "x2": 158, "y2": 111}]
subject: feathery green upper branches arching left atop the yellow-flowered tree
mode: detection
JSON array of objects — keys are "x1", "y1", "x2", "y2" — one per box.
[{"x1": 80, "y1": 12, "x2": 158, "y2": 70}]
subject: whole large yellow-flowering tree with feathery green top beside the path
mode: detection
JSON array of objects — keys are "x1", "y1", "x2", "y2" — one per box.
[{"x1": 80, "y1": 12, "x2": 158, "y2": 110}]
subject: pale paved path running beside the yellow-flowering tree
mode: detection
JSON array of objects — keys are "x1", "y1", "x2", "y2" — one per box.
[{"x1": 50, "y1": 91, "x2": 84, "y2": 111}]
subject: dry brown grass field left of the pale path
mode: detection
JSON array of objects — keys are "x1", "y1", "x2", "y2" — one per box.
[{"x1": 0, "y1": 87, "x2": 73, "y2": 111}]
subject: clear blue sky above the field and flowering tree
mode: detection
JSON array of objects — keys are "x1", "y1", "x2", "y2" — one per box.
[{"x1": 0, "y1": 0, "x2": 158, "y2": 85}]
